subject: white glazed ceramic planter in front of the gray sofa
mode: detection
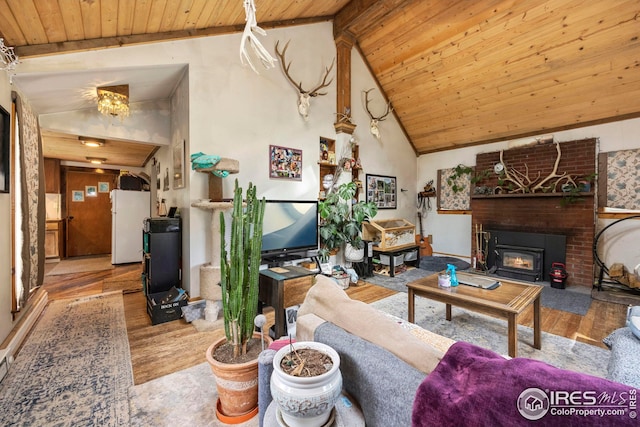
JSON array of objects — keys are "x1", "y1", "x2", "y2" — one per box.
[{"x1": 271, "y1": 341, "x2": 342, "y2": 427}]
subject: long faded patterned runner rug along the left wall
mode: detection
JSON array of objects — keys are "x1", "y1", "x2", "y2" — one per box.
[{"x1": 0, "y1": 292, "x2": 133, "y2": 426}]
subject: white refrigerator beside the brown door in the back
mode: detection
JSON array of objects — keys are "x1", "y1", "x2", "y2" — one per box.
[{"x1": 110, "y1": 190, "x2": 151, "y2": 264}]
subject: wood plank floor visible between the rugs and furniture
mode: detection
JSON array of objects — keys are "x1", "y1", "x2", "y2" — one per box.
[{"x1": 44, "y1": 264, "x2": 626, "y2": 384}]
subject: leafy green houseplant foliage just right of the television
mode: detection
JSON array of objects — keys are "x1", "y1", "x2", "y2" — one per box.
[{"x1": 318, "y1": 182, "x2": 378, "y2": 262}]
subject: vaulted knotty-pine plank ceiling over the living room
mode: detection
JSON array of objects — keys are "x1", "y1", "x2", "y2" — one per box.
[{"x1": 0, "y1": 0, "x2": 640, "y2": 154}]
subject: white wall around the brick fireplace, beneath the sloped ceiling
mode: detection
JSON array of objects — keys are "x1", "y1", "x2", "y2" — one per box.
[{"x1": 416, "y1": 119, "x2": 640, "y2": 270}]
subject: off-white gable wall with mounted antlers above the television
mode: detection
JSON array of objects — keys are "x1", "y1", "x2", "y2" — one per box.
[{"x1": 8, "y1": 22, "x2": 416, "y2": 296}]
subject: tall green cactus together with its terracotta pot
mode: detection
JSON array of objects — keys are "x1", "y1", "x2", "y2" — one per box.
[{"x1": 206, "y1": 180, "x2": 265, "y2": 421}]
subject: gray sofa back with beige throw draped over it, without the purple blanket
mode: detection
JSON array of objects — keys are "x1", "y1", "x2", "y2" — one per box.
[{"x1": 259, "y1": 276, "x2": 453, "y2": 427}]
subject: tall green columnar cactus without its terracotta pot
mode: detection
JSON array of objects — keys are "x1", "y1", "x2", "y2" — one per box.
[{"x1": 220, "y1": 180, "x2": 265, "y2": 357}]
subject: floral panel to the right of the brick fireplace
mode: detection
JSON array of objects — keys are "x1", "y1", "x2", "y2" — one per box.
[{"x1": 607, "y1": 150, "x2": 640, "y2": 209}]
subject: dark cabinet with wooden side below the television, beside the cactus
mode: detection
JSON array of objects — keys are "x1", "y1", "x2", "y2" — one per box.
[{"x1": 258, "y1": 266, "x2": 316, "y2": 339}]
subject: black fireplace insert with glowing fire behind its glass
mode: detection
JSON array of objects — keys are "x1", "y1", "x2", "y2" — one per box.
[{"x1": 496, "y1": 245, "x2": 544, "y2": 282}]
